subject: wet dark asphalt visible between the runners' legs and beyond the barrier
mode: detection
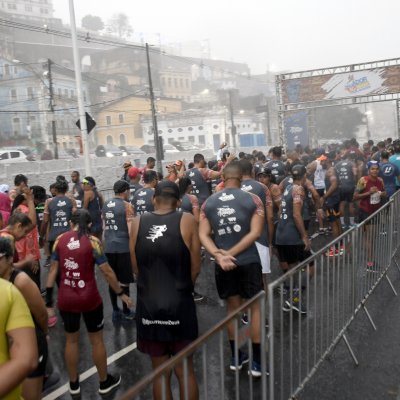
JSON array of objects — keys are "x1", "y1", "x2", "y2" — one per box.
[{"x1": 42, "y1": 227, "x2": 400, "y2": 400}]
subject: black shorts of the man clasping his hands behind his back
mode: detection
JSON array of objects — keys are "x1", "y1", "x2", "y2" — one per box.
[{"x1": 215, "y1": 263, "x2": 263, "y2": 299}]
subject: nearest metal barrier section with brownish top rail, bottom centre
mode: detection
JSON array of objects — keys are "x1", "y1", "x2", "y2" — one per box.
[{"x1": 120, "y1": 292, "x2": 267, "y2": 400}]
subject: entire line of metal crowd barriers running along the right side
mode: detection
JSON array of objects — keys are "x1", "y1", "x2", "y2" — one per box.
[{"x1": 121, "y1": 192, "x2": 400, "y2": 400}]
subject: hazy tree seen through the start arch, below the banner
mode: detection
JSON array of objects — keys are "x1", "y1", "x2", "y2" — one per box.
[{"x1": 315, "y1": 106, "x2": 365, "y2": 140}]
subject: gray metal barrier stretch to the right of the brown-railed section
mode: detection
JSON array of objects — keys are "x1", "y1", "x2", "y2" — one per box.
[{"x1": 268, "y1": 193, "x2": 400, "y2": 400}]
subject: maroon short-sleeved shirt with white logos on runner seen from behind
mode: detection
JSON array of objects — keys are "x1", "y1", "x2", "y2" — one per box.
[{"x1": 52, "y1": 231, "x2": 107, "y2": 312}]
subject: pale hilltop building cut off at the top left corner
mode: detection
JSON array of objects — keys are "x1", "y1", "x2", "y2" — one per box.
[{"x1": 0, "y1": 0, "x2": 54, "y2": 22}]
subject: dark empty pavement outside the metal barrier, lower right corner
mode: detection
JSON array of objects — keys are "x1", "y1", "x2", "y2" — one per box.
[{"x1": 298, "y1": 266, "x2": 400, "y2": 400}]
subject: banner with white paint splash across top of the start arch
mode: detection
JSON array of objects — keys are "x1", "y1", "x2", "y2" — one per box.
[{"x1": 282, "y1": 65, "x2": 400, "y2": 104}]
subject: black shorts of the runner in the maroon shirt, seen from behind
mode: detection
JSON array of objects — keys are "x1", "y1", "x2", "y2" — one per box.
[{"x1": 60, "y1": 303, "x2": 104, "y2": 333}]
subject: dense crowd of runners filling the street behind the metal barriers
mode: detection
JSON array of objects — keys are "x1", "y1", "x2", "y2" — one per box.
[{"x1": 0, "y1": 138, "x2": 400, "y2": 400}]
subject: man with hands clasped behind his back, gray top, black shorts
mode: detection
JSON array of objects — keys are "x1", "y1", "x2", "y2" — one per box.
[{"x1": 199, "y1": 161, "x2": 265, "y2": 377}]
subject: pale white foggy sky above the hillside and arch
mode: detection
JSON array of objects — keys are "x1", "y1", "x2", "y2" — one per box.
[{"x1": 53, "y1": 0, "x2": 400, "y2": 74}]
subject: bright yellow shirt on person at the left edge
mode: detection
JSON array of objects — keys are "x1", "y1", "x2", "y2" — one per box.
[{"x1": 0, "y1": 279, "x2": 34, "y2": 400}]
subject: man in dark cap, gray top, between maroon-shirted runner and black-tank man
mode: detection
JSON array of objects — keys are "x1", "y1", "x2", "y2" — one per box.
[{"x1": 102, "y1": 180, "x2": 135, "y2": 322}]
